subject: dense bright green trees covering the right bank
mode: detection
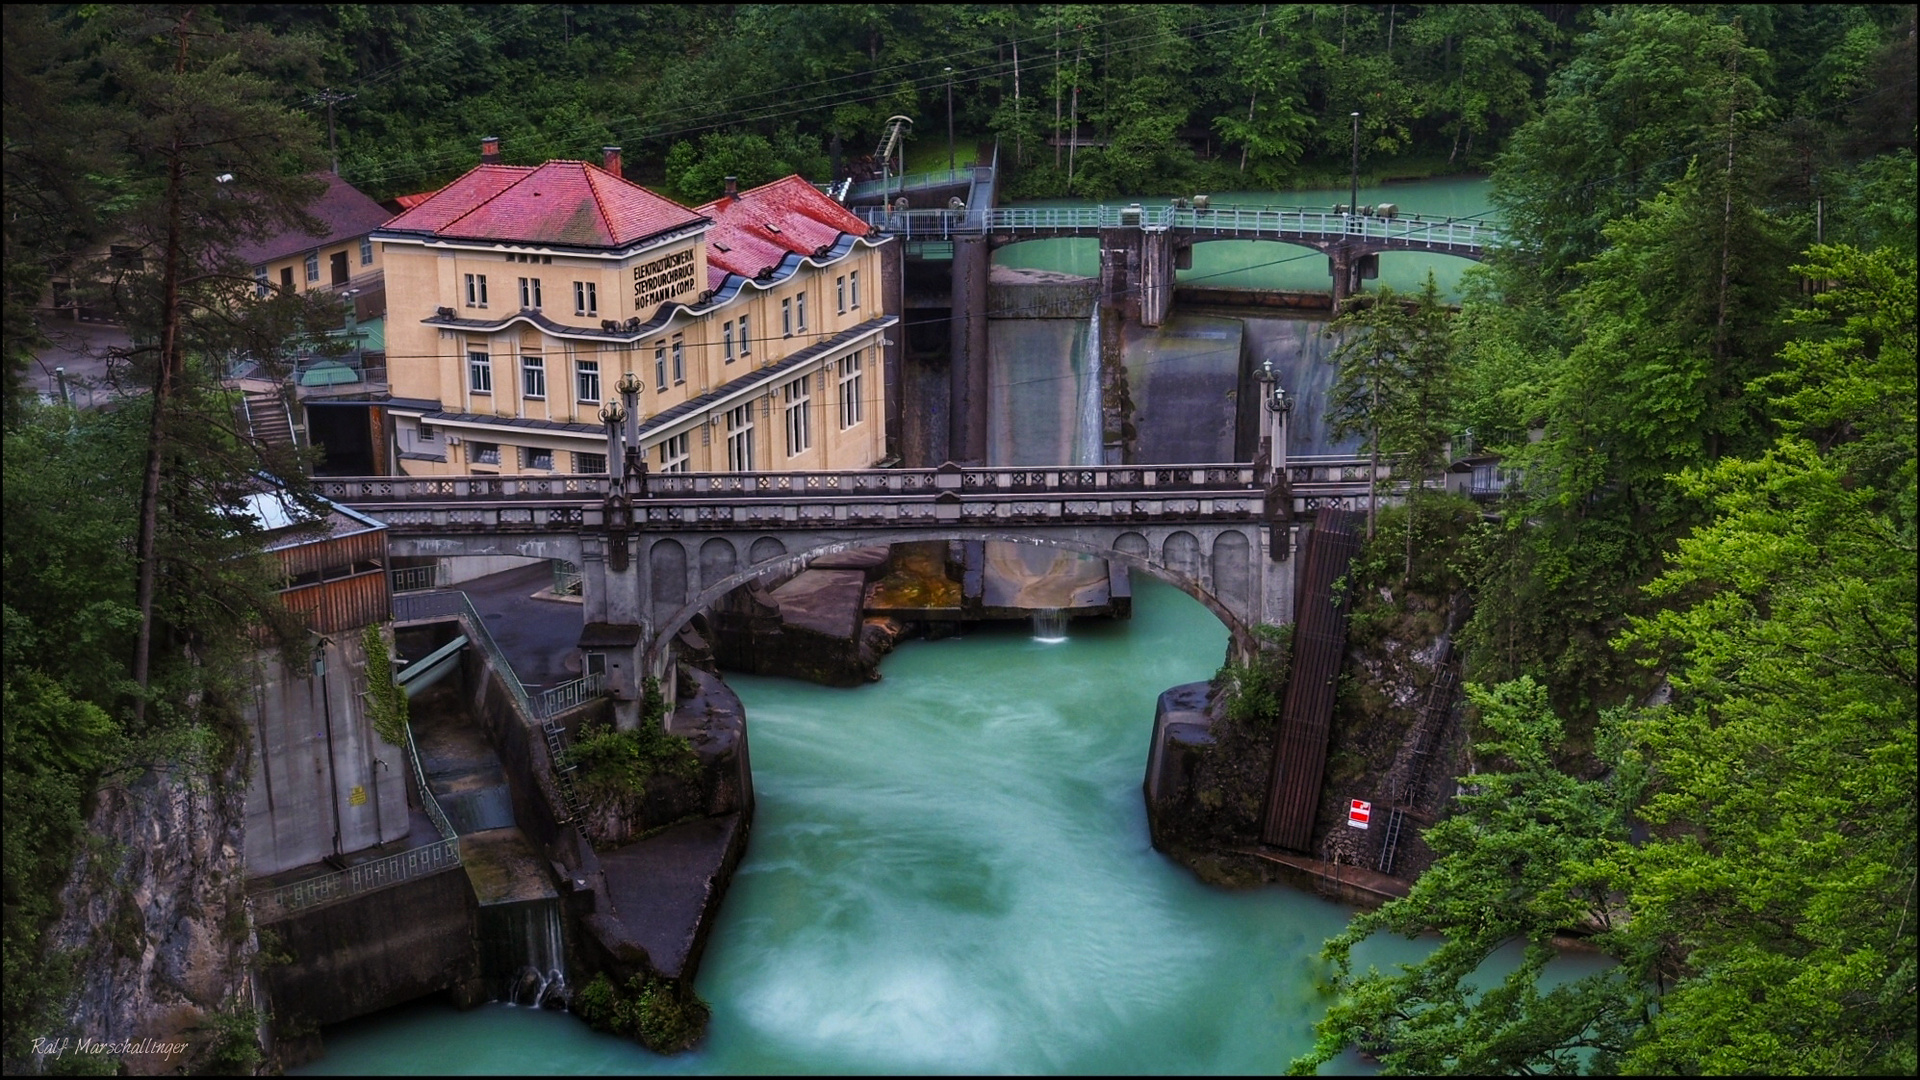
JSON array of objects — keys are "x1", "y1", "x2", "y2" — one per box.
[{"x1": 1294, "y1": 6, "x2": 1920, "y2": 1074}]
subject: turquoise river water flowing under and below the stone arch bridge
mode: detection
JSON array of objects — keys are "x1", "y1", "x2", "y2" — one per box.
[{"x1": 298, "y1": 577, "x2": 1597, "y2": 1074}]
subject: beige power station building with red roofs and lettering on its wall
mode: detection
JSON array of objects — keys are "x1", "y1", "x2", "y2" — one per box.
[{"x1": 372, "y1": 146, "x2": 897, "y2": 477}]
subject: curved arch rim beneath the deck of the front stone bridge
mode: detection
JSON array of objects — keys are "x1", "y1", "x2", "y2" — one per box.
[{"x1": 643, "y1": 528, "x2": 1258, "y2": 680}]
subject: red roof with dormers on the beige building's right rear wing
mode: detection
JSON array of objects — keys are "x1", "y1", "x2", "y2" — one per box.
[{"x1": 699, "y1": 177, "x2": 868, "y2": 288}]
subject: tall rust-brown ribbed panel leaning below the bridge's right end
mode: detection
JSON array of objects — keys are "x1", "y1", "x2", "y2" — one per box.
[{"x1": 1260, "y1": 509, "x2": 1359, "y2": 853}]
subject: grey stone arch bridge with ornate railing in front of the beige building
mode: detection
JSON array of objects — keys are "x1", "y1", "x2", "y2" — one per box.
[{"x1": 317, "y1": 457, "x2": 1386, "y2": 723}]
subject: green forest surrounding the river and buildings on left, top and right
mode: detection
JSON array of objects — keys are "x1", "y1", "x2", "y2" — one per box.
[{"x1": 4, "y1": 4, "x2": 1920, "y2": 1074}]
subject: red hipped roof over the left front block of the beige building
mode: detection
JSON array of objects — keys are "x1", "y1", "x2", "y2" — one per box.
[{"x1": 388, "y1": 161, "x2": 701, "y2": 248}]
